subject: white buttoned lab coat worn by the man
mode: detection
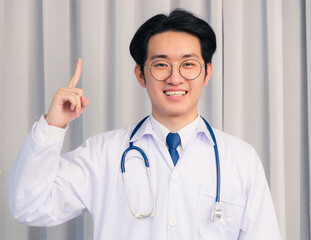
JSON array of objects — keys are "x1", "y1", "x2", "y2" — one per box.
[{"x1": 9, "y1": 115, "x2": 280, "y2": 240}]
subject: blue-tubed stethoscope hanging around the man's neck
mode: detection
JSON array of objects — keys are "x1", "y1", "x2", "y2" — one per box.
[{"x1": 121, "y1": 116, "x2": 222, "y2": 221}]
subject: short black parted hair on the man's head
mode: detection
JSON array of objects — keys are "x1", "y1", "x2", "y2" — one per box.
[{"x1": 130, "y1": 9, "x2": 216, "y2": 69}]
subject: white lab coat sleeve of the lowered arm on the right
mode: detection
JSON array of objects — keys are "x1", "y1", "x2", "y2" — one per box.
[{"x1": 238, "y1": 150, "x2": 281, "y2": 240}]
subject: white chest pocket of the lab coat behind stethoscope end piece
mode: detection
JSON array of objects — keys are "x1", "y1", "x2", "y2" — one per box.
[{"x1": 197, "y1": 186, "x2": 245, "y2": 240}]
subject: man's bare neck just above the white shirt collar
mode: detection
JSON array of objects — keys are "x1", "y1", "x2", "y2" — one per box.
[{"x1": 152, "y1": 113, "x2": 198, "y2": 132}]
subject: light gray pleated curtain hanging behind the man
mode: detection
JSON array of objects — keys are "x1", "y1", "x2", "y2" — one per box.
[{"x1": 0, "y1": 0, "x2": 311, "y2": 240}]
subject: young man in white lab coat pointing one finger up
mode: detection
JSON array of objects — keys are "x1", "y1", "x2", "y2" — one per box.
[{"x1": 10, "y1": 10, "x2": 280, "y2": 240}]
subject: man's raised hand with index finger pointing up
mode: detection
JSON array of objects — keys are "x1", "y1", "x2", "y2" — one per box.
[{"x1": 45, "y1": 58, "x2": 89, "y2": 127}]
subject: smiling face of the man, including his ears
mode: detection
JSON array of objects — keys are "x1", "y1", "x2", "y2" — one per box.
[{"x1": 135, "y1": 31, "x2": 212, "y2": 123}]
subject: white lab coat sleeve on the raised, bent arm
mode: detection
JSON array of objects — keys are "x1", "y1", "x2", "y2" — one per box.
[{"x1": 9, "y1": 117, "x2": 92, "y2": 226}]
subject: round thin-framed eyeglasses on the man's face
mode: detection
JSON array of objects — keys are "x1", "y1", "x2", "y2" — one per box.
[{"x1": 145, "y1": 59, "x2": 204, "y2": 81}]
